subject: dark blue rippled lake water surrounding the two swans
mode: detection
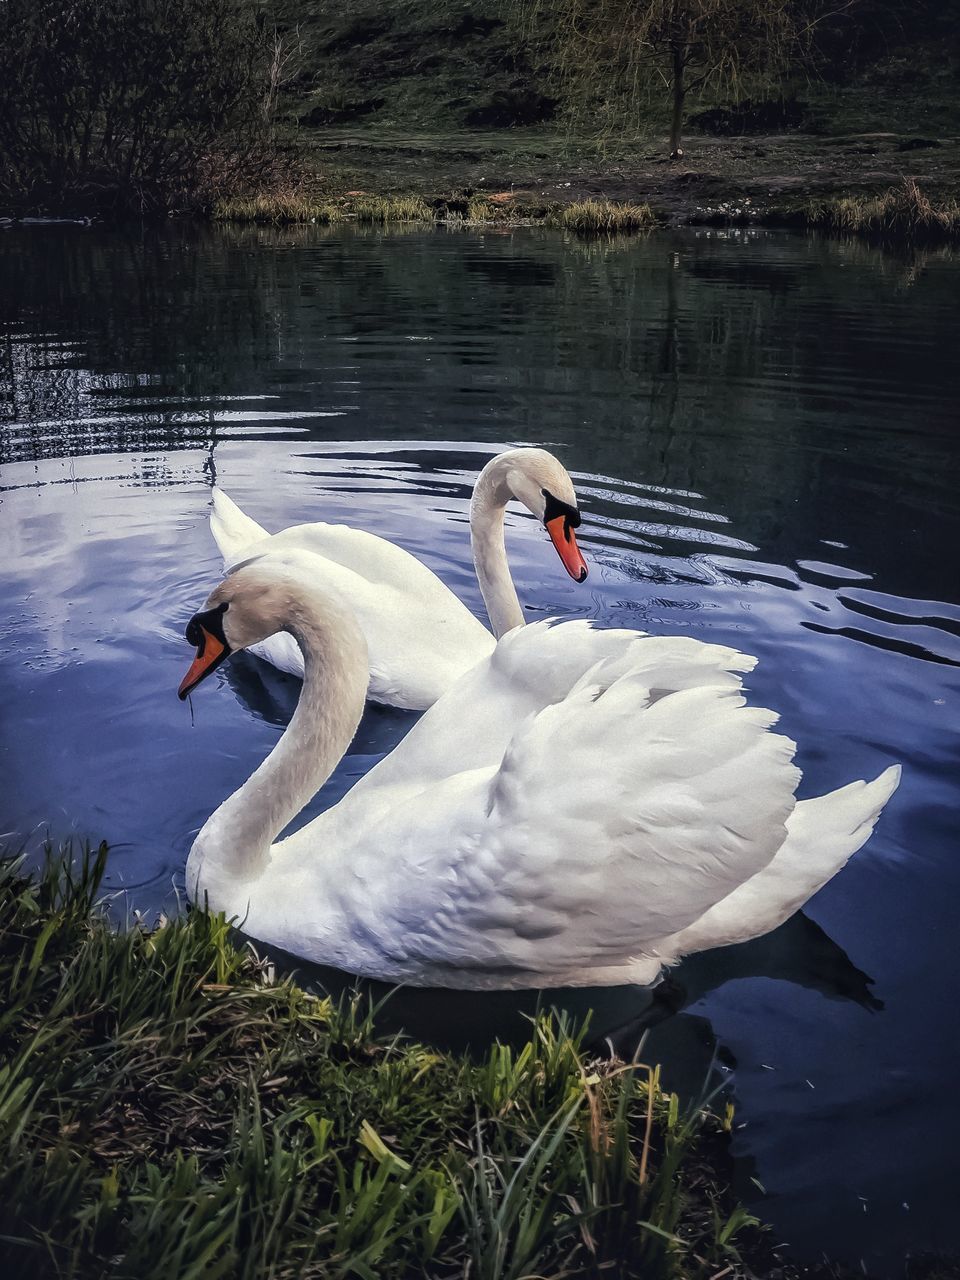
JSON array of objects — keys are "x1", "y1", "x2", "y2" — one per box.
[{"x1": 0, "y1": 224, "x2": 960, "y2": 1274}]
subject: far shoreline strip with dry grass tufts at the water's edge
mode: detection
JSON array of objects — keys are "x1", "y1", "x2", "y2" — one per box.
[{"x1": 7, "y1": 129, "x2": 960, "y2": 247}]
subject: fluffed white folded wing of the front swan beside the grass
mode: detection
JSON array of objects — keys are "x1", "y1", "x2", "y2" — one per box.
[{"x1": 368, "y1": 664, "x2": 799, "y2": 974}]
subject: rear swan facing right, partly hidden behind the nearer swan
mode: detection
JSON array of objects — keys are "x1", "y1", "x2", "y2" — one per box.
[{"x1": 210, "y1": 448, "x2": 588, "y2": 710}]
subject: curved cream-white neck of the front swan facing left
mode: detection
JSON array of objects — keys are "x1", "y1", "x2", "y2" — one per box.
[{"x1": 187, "y1": 596, "x2": 369, "y2": 910}]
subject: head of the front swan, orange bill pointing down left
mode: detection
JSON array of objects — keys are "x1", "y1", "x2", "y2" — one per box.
[{"x1": 178, "y1": 552, "x2": 343, "y2": 699}]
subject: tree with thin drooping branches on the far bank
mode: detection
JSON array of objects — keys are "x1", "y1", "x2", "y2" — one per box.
[{"x1": 521, "y1": 0, "x2": 856, "y2": 157}]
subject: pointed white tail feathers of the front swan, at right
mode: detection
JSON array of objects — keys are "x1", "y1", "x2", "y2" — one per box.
[{"x1": 655, "y1": 764, "x2": 900, "y2": 961}]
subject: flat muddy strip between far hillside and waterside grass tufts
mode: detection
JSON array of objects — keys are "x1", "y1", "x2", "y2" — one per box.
[{"x1": 296, "y1": 129, "x2": 960, "y2": 225}]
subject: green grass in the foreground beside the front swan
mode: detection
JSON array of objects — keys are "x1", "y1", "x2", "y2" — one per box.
[{"x1": 0, "y1": 846, "x2": 773, "y2": 1280}]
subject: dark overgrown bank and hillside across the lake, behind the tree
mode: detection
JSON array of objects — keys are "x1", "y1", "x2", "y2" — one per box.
[{"x1": 7, "y1": 0, "x2": 960, "y2": 239}]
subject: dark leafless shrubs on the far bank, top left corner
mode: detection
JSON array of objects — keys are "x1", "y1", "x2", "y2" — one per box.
[{"x1": 0, "y1": 0, "x2": 281, "y2": 211}]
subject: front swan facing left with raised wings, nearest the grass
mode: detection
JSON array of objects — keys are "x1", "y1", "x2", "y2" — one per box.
[{"x1": 179, "y1": 550, "x2": 900, "y2": 989}]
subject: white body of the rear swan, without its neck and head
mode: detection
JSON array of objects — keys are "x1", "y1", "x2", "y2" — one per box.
[{"x1": 210, "y1": 489, "x2": 495, "y2": 710}]
